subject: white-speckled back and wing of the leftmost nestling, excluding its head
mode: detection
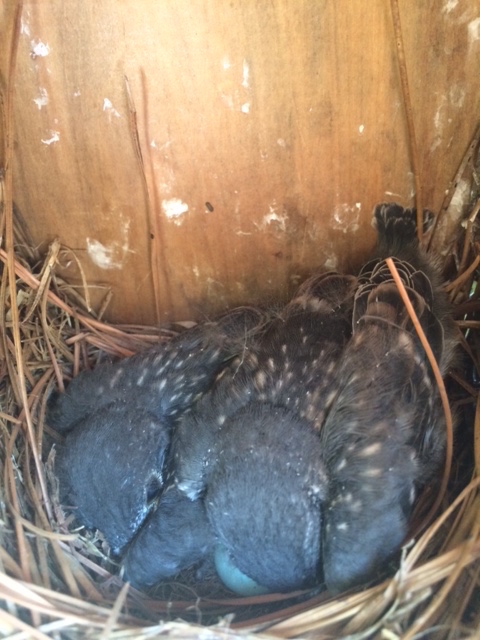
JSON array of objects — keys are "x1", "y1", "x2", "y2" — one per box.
[{"x1": 48, "y1": 307, "x2": 266, "y2": 433}]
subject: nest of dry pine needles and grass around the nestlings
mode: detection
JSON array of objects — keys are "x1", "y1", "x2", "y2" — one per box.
[{"x1": 0, "y1": 134, "x2": 480, "y2": 640}]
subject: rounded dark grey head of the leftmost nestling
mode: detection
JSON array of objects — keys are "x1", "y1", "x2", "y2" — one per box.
[{"x1": 55, "y1": 401, "x2": 170, "y2": 553}]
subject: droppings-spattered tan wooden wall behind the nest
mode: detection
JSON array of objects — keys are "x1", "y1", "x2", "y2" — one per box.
[{"x1": 0, "y1": 0, "x2": 480, "y2": 323}]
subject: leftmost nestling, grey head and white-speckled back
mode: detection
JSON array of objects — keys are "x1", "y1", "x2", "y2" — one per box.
[{"x1": 47, "y1": 308, "x2": 264, "y2": 554}]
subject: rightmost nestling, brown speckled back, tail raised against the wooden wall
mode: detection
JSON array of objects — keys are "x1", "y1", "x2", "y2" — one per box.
[{"x1": 320, "y1": 204, "x2": 457, "y2": 591}]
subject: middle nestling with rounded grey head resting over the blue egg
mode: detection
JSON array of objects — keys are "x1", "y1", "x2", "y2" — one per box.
[{"x1": 126, "y1": 273, "x2": 356, "y2": 593}]
